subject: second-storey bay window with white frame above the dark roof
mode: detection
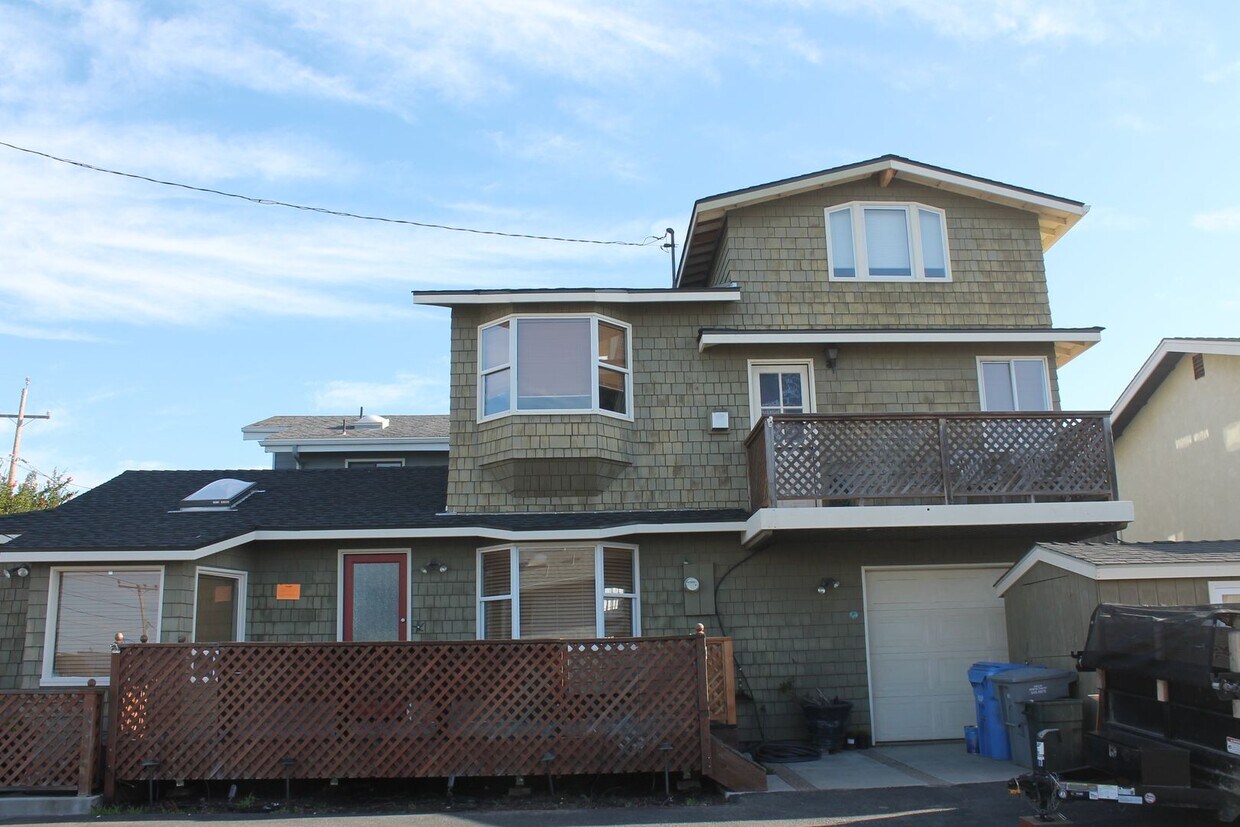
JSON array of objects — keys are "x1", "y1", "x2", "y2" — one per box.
[{"x1": 479, "y1": 315, "x2": 632, "y2": 419}]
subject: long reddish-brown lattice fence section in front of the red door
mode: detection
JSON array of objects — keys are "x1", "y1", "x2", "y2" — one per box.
[{"x1": 109, "y1": 637, "x2": 703, "y2": 781}]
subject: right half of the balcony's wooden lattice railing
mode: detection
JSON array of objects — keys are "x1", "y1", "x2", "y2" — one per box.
[{"x1": 946, "y1": 417, "x2": 1112, "y2": 500}]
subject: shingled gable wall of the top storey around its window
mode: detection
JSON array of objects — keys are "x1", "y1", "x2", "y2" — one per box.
[{"x1": 712, "y1": 177, "x2": 1050, "y2": 329}]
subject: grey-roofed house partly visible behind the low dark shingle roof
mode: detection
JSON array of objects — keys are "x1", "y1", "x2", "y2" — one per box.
[{"x1": 241, "y1": 413, "x2": 448, "y2": 469}]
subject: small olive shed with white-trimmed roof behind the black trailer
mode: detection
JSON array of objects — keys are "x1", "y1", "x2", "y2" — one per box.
[{"x1": 996, "y1": 539, "x2": 1240, "y2": 694}]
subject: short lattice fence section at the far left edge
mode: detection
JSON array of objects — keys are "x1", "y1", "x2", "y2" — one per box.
[{"x1": 0, "y1": 689, "x2": 99, "y2": 791}]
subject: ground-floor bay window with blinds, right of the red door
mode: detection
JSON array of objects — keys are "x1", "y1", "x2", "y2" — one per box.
[{"x1": 477, "y1": 544, "x2": 640, "y2": 640}]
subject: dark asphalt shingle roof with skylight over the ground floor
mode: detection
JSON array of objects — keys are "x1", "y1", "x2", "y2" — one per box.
[{"x1": 0, "y1": 467, "x2": 748, "y2": 557}]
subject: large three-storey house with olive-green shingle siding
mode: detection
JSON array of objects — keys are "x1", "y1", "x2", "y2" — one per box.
[{"x1": 0, "y1": 156, "x2": 1132, "y2": 741}]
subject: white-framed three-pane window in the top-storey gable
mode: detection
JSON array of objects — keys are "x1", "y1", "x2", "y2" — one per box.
[{"x1": 826, "y1": 201, "x2": 951, "y2": 281}]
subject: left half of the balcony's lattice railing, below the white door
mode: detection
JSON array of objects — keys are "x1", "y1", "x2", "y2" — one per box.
[{"x1": 774, "y1": 418, "x2": 944, "y2": 501}]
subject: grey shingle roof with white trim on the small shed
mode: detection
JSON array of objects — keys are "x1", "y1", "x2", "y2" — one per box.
[{"x1": 994, "y1": 539, "x2": 1240, "y2": 595}]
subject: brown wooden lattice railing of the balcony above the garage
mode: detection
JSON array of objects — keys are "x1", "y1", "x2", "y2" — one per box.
[{"x1": 745, "y1": 412, "x2": 1117, "y2": 511}]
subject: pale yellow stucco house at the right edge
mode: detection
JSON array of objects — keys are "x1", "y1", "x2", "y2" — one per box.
[{"x1": 1111, "y1": 338, "x2": 1240, "y2": 541}]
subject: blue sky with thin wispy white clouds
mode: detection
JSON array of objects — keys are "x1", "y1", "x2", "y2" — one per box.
[{"x1": 0, "y1": 0, "x2": 1240, "y2": 487}]
